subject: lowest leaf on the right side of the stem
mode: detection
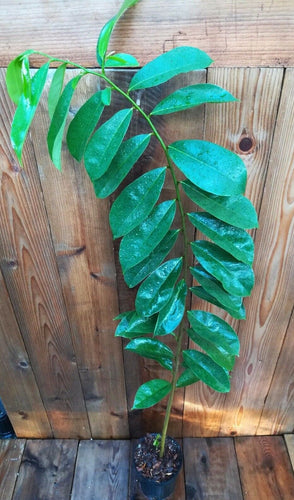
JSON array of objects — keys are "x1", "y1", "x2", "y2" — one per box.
[{"x1": 183, "y1": 349, "x2": 230, "y2": 392}]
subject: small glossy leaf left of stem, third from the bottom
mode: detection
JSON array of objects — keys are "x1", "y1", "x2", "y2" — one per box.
[{"x1": 115, "y1": 311, "x2": 156, "y2": 338}]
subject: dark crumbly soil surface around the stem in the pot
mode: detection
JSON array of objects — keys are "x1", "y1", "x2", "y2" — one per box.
[{"x1": 134, "y1": 434, "x2": 182, "y2": 483}]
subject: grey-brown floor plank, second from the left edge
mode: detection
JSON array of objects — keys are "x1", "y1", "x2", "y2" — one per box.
[{"x1": 13, "y1": 439, "x2": 78, "y2": 500}]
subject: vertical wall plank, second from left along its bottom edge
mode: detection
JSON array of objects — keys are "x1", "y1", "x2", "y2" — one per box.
[{"x1": 0, "y1": 70, "x2": 90, "y2": 437}]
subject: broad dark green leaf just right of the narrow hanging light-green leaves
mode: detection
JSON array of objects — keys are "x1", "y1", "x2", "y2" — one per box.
[{"x1": 66, "y1": 90, "x2": 104, "y2": 161}]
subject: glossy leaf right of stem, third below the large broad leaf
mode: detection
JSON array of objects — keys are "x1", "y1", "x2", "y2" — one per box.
[{"x1": 191, "y1": 240, "x2": 254, "y2": 297}]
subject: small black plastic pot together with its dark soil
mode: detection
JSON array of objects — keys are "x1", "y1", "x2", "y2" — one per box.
[{"x1": 134, "y1": 434, "x2": 183, "y2": 500}]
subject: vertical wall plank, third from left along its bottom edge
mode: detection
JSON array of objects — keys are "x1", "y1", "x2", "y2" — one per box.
[{"x1": 32, "y1": 70, "x2": 128, "y2": 438}]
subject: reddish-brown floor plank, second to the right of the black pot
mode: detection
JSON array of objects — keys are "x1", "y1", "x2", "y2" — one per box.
[{"x1": 235, "y1": 436, "x2": 294, "y2": 500}]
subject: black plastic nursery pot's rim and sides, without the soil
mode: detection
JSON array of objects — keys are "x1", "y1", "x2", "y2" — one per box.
[{"x1": 135, "y1": 434, "x2": 183, "y2": 500}]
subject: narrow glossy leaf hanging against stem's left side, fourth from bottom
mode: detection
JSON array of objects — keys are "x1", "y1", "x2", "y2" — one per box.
[{"x1": 154, "y1": 280, "x2": 187, "y2": 336}]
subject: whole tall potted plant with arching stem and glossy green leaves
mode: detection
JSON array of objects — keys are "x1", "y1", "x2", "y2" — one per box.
[{"x1": 6, "y1": 0, "x2": 258, "y2": 498}]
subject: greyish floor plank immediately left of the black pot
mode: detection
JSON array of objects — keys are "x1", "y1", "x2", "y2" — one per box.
[{"x1": 71, "y1": 440, "x2": 130, "y2": 500}]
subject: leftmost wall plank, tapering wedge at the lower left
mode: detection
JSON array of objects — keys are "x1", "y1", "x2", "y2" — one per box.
[{"x1": 0, "y1": 272, "x2": 52, "y2": 438}]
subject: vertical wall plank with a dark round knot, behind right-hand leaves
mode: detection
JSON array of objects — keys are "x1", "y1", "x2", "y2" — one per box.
[{"x1": 184, "y1": 68, "x2": 283, "y2": 436}]
